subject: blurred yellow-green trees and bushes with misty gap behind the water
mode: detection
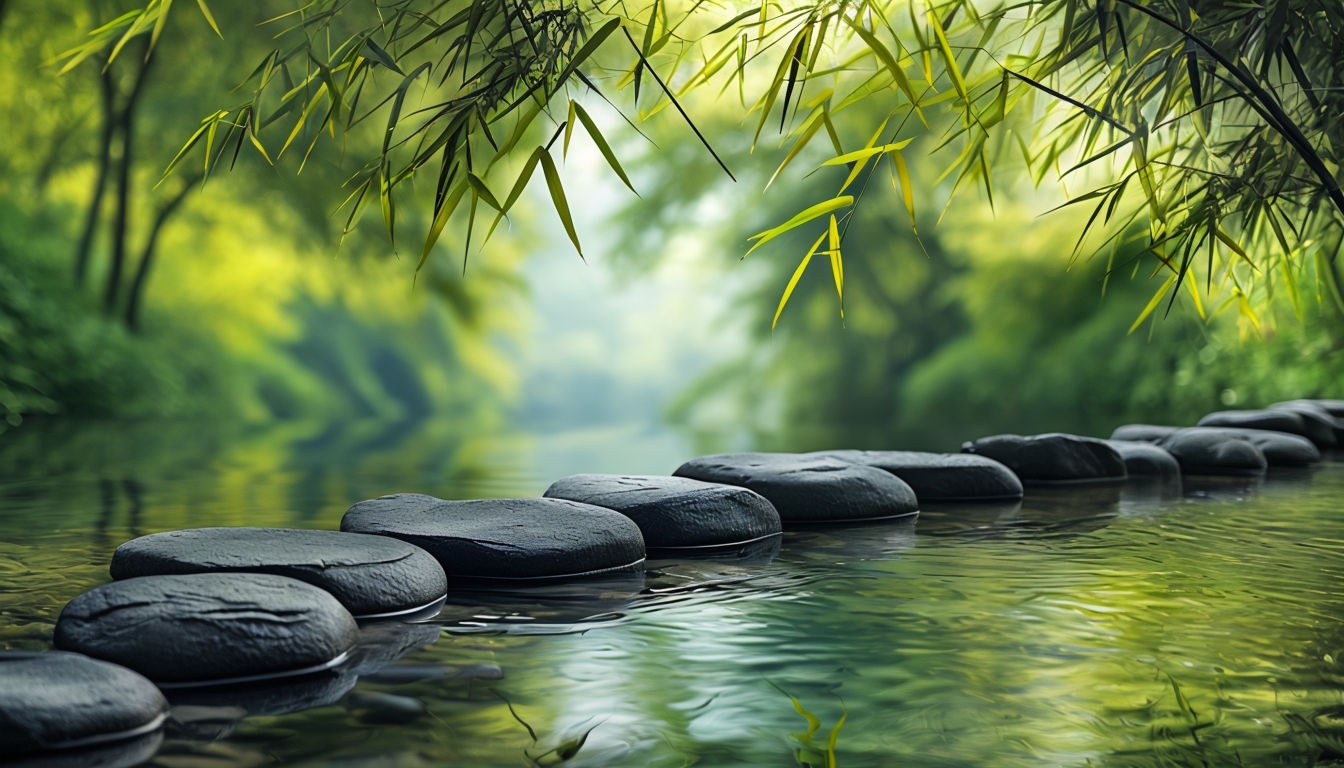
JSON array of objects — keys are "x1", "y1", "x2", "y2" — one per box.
[{"x1": 0, "y1": 0, "x2": 1344, "y2": 462}]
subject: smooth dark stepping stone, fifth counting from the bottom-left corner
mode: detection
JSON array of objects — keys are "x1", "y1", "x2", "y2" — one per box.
[{"x1": 543, "y1": 475, "x2": 781, "y2": 554}]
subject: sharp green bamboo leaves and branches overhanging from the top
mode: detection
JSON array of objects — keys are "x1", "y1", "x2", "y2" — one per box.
[{"x1": 71, "y1": 0, "x2": 1344, "y2": 328}]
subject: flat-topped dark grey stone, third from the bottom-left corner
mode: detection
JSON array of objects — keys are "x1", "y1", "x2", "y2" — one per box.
[{"x1": 110, "y1": 527, "x2": 448, "y2": 619}]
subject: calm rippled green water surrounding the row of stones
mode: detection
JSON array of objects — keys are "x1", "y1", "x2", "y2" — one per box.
[{"x1": 0, "y1": 425, "x2": 1344, "y2": 768}]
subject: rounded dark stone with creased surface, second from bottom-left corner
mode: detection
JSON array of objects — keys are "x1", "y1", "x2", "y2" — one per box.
[{"x1": 55, "y1": 573, "x2": 359, "y2": 687}]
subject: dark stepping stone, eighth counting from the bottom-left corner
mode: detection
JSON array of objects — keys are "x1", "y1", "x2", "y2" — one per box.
[{"x1": 961, "y1": 432, "x2": 1126, "y2": 486}]
